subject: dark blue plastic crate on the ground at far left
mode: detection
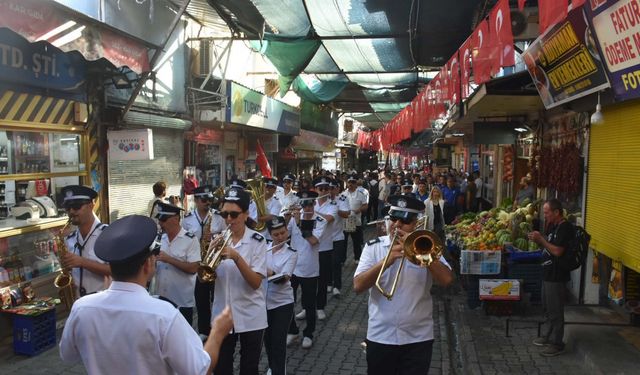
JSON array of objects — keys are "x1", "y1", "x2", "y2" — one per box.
[{"x1": 13, "y1": 310, "x2": 56, "y2": 356}]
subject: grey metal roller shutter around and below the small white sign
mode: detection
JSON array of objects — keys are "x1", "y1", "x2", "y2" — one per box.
[{"x1": 109, "y1": 128, "x2": 184, "y2": 221}]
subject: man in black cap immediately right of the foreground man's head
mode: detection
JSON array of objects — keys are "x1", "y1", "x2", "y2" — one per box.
[{"x1": 156, "y1": 202, "x2": 200, "y2": 324}]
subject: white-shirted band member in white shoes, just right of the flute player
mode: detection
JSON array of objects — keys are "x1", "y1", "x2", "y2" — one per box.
[{"x1": 287, "y1": 191, "x2": 327, "y2": 349}]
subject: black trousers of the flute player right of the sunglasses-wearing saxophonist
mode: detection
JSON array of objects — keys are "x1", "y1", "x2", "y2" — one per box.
[{"x1": 264, "y1": 303, "x2": 293, "y2": 375}]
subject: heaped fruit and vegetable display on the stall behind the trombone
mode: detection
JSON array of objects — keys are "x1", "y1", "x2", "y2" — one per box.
[{"x1": 447, "y1": 202, "x2": 540, "y2": 251}]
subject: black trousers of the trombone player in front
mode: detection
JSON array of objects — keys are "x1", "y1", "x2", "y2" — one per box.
[{"x1": 367, "y1": 340, "x2": 433, "y2": 375}]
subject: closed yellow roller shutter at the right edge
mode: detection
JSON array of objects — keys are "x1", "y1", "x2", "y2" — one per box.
[{"x1": 586, "y1": 101, "x2": 640, "y2": 272}]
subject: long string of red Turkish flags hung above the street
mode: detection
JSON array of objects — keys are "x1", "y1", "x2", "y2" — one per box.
[{"x1": 356, "y1": 0, "x2": 586, "y2": 151}]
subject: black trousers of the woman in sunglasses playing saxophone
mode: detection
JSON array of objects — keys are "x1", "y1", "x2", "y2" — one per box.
[{"x1": 213, "y1": 329, "x2": 264, "y2": 375}]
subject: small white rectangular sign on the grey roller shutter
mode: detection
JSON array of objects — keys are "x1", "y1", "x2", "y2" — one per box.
[{"x1": 107, "y1": 129, "x2": 153, "y2": 161}]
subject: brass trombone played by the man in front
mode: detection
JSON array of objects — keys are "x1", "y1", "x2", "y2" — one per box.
[{"x1": 376, "y1": 216, "x2": 444, "y2": 301}]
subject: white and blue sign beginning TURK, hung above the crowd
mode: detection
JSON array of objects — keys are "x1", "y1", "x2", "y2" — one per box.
[{"x1": 226, "y1": 82, "x2": 300, "y2": 135}]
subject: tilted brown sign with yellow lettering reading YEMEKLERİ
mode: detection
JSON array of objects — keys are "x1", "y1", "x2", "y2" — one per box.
[{"x1": 522, "y1": 9, "x2": 609, "y2": 109}]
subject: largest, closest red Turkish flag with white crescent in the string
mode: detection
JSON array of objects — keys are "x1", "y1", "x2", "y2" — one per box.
[{"x1": 489, "y1": 0, "x2": 516, "y2": 74}]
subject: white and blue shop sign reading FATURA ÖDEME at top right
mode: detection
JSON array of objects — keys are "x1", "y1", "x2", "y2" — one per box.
[{"x1": 584, "y1": 0, "x2": 640, "y2": 100}]
